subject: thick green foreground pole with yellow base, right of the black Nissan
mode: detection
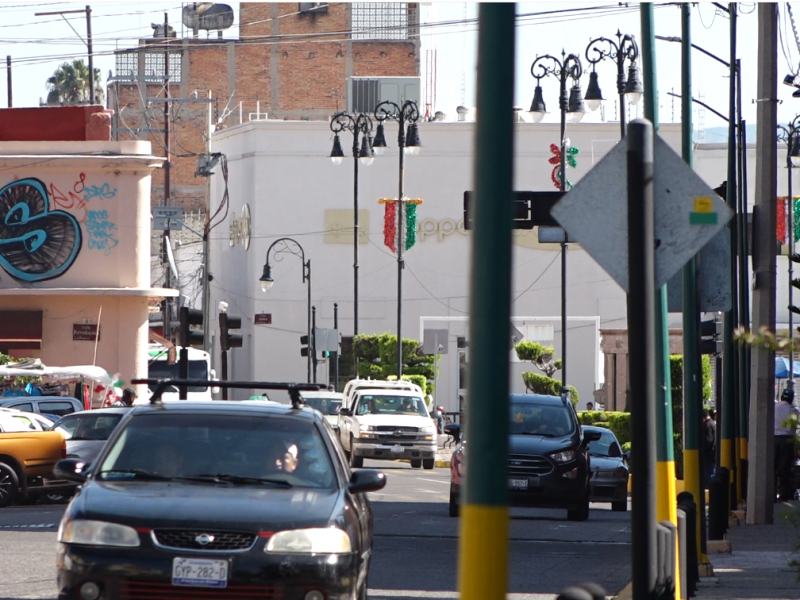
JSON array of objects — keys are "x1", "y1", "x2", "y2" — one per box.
[{"x1": 458, "y1": 3, "x2": 515, "y2": 600}]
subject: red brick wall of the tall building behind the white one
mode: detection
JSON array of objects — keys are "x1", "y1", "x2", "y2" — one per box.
[{"x1": 113, "y1": 2, "x2": 420, "y2": 211}]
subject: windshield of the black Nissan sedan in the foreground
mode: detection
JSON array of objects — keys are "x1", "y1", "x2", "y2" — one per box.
[{"x1": 96, "y1": 413, "x2": 336, "y2": 488}]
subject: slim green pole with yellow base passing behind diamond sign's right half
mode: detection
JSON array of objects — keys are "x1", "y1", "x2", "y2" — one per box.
[{"x1": 681, "y1": 2, "x2": 705, "y2": 556}]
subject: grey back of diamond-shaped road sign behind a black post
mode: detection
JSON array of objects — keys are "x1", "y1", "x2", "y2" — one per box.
[{"x1": 550, "y1": 136, "x2": 732, "y2": 292}]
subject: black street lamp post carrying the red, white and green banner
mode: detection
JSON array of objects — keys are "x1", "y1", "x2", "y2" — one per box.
[{"x1": 372, "y1": 100, "x2": 420, "y2": 380}]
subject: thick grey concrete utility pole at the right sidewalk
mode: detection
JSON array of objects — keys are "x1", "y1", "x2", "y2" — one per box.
[{"x1": 746, "y1": 3, "x2": 778, "y2": 524}]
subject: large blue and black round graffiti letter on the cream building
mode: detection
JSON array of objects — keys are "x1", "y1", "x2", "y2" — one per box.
[{"x1": 0, "y1": 177, "x2": 82, "y2": 282}]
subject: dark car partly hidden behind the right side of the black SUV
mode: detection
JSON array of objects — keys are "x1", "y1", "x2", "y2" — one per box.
[{"x1": 583, "y1": 425, "x2": 628, "y2": 512}]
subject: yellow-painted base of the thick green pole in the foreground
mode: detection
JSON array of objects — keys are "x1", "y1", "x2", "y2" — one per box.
[{"x1": 458, "y1": 504, "x2": 509, "y2": 600}]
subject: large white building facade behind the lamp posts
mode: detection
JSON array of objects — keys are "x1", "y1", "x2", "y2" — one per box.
[{"x1": 210, "y1": 121, "x2": 764, "y2": 411}]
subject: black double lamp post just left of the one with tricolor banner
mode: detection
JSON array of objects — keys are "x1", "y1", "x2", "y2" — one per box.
[{"x1": 330, "y1": 112, "x2": 376, "y2": 350}]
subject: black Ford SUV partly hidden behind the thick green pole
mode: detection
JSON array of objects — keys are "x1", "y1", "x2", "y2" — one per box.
[{"x1": 449, "y1": 394, "x2": 600, "y2": 521}]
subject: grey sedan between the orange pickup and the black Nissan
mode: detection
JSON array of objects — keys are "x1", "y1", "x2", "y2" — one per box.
[{"x1": 50, "y1": 407, "x2": 130, "y2": 462}]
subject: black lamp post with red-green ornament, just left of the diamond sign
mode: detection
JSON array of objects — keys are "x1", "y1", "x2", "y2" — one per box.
[{"x1": 530, "y1": 51, "x2": 586, "y2": 385}]
